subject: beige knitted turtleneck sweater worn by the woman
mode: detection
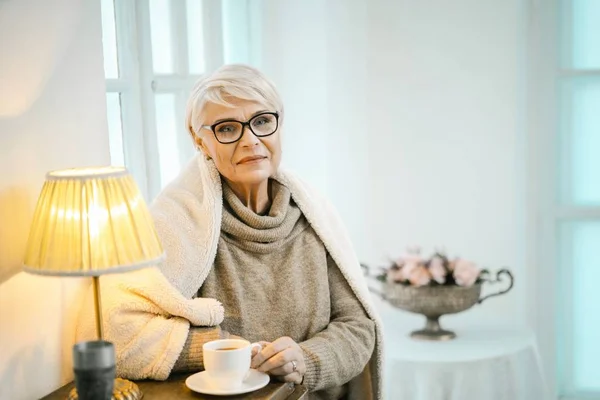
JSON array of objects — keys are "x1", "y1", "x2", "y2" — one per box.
[{"x1": 175, "y1": 181, "x2": 375, "y2": 399}]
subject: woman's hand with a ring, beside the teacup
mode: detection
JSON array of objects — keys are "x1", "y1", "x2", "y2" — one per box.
[{"x1": 251, "y1": 336, "x2": 306, "y2": 384}]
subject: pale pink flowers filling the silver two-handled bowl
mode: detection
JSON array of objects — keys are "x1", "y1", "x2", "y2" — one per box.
[{"x1": 379, "y1": 248, "x2": 487, "y2": 287}]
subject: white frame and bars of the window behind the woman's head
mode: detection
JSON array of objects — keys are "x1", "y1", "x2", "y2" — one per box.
[{"x1": 106, "y1": 0, "x2": 236, "y2": 201}]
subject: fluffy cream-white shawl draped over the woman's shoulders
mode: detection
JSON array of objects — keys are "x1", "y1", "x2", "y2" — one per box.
[{"x1": 77, "y1": 154, "x2": 383, "y2": 399}]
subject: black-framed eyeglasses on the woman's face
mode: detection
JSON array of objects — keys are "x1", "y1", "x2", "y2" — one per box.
[{"x1": 200, "y1": 112, "x2": 279, "y2": 144}]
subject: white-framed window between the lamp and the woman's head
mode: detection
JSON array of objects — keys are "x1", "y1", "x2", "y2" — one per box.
[{"x1": 101, "y1": 0, "x2": 251, "y2": 200}]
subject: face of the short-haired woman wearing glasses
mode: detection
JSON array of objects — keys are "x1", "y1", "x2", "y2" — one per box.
[{"x1": 196, "y1": 99, "x2": 281, "y2": 185}]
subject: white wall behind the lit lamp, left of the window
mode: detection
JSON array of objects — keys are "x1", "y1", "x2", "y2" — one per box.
[{"x1": 0, "y1": 0, "x2": 110, "y2": 400}]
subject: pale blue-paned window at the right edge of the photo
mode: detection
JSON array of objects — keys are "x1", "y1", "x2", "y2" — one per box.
[{"x1": 552, "y1": 0, "x2": 600, "y2": 399}]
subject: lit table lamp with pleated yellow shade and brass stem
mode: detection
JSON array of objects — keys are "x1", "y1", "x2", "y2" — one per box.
[{"x1": 24, "y1": 167, "x2": 164, "y2": 399}]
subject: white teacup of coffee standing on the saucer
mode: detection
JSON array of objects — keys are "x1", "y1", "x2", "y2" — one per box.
[{"x1": 202, "y1": 339, "x2": 262, "y2": 389}]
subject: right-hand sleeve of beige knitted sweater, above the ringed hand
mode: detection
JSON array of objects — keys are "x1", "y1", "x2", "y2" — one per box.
[{"x1": 300, "y1": 255, "x2": 375, "y2": 392}]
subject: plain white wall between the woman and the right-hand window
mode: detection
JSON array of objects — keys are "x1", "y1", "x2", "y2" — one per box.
[{"x1": 255, "y1": 0, "x2": 528, "y2": 327}]
